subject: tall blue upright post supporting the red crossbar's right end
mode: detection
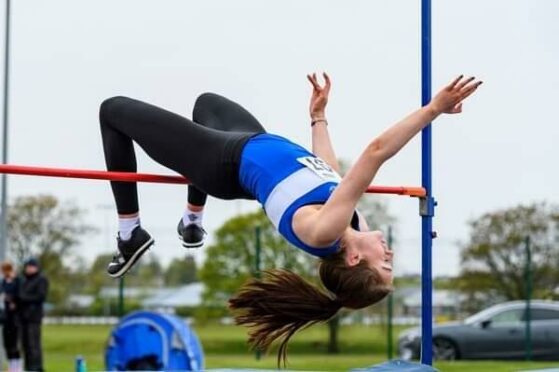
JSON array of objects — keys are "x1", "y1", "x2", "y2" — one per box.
[{"x1": 420, "y1": 0, "x2": 436, "y2": 365}]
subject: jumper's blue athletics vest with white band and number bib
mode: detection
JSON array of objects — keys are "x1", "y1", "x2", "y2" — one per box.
[{"x1": 239, "y1": 133, "x2": 358, "y2": 257}]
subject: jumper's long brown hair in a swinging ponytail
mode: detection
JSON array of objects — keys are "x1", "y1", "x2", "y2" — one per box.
[{"x1": 229, "y1": 250, "x2": 392, "y2": 367}]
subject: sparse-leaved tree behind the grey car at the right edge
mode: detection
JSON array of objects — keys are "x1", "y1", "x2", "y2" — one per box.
[{"x1": 458, "y1": 203, "x2": 559, "y2": 310}]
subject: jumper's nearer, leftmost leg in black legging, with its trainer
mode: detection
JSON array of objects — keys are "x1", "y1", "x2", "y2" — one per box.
[{"x1": 100, "y1": 97, "x2": 250, "y2": 276}]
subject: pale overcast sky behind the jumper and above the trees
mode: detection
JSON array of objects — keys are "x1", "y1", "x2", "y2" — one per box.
[{"x1": 0, "y1": 0, "x2": 559, "y2": 276}]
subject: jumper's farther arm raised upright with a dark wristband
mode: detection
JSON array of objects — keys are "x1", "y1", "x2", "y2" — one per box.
[{"x1": 307, "y1": 73, "x2": 340, "y2": 173}]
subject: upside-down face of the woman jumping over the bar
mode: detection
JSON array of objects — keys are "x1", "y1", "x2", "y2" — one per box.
[{"x1": 346, "y1": 231, "x2": 393, "y2": 284}]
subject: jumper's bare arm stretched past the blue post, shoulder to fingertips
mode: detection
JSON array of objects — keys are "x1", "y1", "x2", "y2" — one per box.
[{"x1": 294, "y1": 76, "x2": 481, "y2": 247}]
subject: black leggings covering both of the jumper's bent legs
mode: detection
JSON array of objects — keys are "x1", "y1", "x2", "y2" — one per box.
[{"x1": 99, "y1": 93, "x2": 265, "y2": 214}]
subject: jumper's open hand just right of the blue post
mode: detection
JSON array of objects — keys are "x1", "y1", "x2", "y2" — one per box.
[{"x1": 429, "y1": 75, "x2": 482, "y2": 114}]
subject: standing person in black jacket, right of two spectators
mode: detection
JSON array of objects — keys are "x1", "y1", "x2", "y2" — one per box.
[{"x1": 19, "y1": 258, "x2": 49, "y2": 371}]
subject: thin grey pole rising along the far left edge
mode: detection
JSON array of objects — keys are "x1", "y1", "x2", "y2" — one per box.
[{"x1": 0, "y1": 0, "x2": 11, "y2": 261}]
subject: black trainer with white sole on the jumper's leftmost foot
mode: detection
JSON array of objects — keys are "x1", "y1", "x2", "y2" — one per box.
[{"x1": 107, "y1": 226, "x2": 154, "y2": 278}]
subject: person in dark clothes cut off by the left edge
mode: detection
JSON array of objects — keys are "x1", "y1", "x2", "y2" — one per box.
[{"x1": 0, "y1": 261, "x2": 21, "y2": 372}]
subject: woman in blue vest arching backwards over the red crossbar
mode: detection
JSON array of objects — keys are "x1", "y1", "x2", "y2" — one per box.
[{"x1": 100, "y1": 74, "x2": 481, "y2": 361}]
